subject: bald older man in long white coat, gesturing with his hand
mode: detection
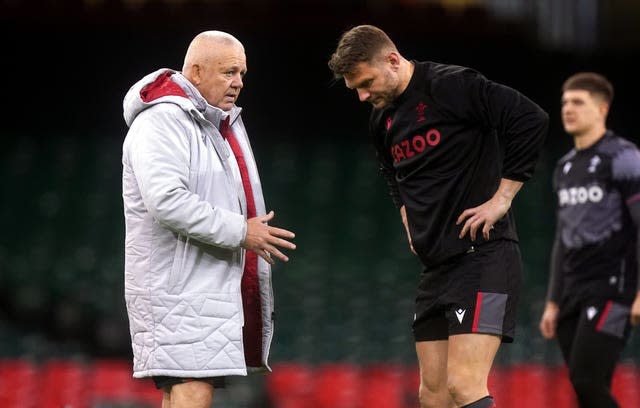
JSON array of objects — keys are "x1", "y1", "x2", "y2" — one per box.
[{"x1": 122, "y1": 31, "x2": 295, "y2": 408}]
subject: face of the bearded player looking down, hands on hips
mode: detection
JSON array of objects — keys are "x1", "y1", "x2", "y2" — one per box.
[{"x1": 344, "y1": 61, "x2": 399, "y2": 109}]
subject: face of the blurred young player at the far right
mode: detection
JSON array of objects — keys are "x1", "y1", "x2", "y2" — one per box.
[{"x1": 562, "y1": 90, "x2": 607, "y2": 136}]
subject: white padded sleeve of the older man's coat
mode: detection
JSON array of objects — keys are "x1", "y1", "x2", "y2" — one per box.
[{"x1": 123, "y1": 106, "x2": 246, "y2": 249}]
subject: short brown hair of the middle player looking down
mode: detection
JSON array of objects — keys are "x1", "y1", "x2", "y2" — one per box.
[{"x1": 328, "y1": 24, "x2": 395, "y2": 79}]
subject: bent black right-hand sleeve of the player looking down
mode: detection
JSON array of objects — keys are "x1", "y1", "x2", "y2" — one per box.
[{"x1": 432, "y1": 69, "x2": 549, "y2": 181}]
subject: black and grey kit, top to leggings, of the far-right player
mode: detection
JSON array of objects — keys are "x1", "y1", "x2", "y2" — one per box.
[{"x1": 548, "y1": 131, "x2": 640, "y2": 408}]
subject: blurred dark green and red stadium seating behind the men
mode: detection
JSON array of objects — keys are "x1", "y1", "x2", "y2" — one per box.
[{"x1": 0, "y1": 136, "x2": 640, "y2": 408}]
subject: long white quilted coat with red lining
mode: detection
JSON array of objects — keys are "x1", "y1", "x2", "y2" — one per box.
[{"x1": 122, "y1": 69, "x2": 273, "y2": 378}]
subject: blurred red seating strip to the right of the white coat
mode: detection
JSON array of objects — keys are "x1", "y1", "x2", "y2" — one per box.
[{"x1": 266, "y1": 363, "x2": 640, "y2": 408}]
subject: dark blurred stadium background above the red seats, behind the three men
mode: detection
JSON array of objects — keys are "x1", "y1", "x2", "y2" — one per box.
[{"x1": 0, "y1": 0, "x2": 640, "y2": 407}]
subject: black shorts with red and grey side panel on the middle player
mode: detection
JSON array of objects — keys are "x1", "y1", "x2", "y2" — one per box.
[{"x1": 413, "y1": 239, "x2": 522, "y2": 343}]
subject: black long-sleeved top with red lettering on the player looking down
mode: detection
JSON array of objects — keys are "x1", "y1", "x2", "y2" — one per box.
[{"x1": 370, "y1": 62, "x2": 549, "y2": 267}]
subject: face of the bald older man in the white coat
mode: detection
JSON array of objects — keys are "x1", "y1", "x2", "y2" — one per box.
[{"x1": 197, "y1": 44, "x2": 247, "y2": 111}]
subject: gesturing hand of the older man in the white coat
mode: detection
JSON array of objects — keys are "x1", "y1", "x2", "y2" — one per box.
[{"x1": 242, "y1": 211, "x2": 296, "y2": 265}]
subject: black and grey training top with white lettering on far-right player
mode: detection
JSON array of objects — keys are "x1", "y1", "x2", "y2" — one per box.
[{"x1": 549, "y1": 131, "x2": 640, "y2": 303}]
